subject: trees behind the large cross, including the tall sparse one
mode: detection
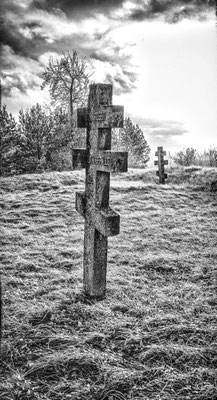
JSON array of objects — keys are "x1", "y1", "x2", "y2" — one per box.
[{"x1": 0, "y1": 50, "x2": 150, "y2": 175}]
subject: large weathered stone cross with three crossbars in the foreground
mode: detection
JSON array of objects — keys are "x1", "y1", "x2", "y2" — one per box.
[{"x1": 73, "y1": 84, "x2": 127, "y2": 297}]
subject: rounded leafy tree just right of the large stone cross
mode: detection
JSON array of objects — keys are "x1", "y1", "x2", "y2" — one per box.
[{"x1": 113, "y1": 117, "x2": 151, "y2": 166}]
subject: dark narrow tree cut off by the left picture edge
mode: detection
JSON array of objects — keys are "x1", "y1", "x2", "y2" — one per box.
[{"x1": 0, "y1": 105, "x2": 18, "y2": 176}]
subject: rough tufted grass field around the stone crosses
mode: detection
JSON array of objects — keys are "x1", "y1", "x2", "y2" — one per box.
[{"x1": 0, "y1": 168, "x2": 217, "y2": 400}]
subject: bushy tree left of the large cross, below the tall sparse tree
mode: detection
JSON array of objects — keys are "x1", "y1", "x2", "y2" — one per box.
[{"x1": 19, "y1": 104, "x2": 72, "y2": 172}]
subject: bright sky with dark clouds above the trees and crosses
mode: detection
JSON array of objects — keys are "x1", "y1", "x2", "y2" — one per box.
[{"x1": 0, "y1": 0, "x2": 217, "y2": 152}]
